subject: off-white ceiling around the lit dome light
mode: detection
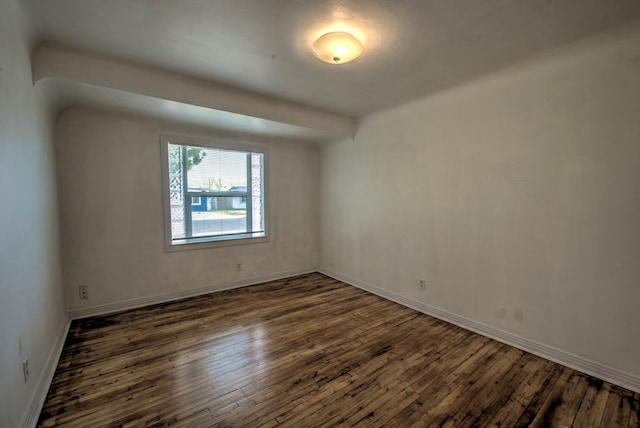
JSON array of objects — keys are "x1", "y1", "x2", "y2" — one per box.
[{"x1": 25, "y1": 0, "x2": 640, "y2": 117}]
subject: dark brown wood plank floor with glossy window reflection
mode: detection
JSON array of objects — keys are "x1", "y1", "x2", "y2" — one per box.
[{"x1": 39, "y1": 274, "x2": 640, "y2": 427}]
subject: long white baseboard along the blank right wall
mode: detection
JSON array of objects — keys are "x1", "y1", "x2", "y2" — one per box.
[{"x1": 318, "y1": 269, "x2": 640, "y2": 392}]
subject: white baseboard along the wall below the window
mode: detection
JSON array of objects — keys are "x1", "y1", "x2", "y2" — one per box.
[{"x1": 68, "y1": 266, "x2": 317, "y2": 319}]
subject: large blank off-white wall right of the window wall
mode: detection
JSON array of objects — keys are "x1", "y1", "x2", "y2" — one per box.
[{"x1": 320, "y1": 23, "x2": 640, "y2": 387}]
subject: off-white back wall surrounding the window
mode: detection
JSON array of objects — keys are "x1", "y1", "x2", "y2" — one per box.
[{"x1": 56, "y1": 109, "x2": 319, "y2": 310}]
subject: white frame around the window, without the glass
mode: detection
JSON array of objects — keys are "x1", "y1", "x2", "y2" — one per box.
[{"x1": 160, "y1": 134, "x2": 270, "y2": 252}]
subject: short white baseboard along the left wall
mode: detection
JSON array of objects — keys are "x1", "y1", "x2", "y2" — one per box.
[{"x1": 20, "y1": 316, "x2": 71, "y2": 428}]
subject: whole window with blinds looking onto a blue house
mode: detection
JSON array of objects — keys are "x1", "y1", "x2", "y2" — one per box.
[{"x1": 161, "y1": 136, "x2": 267, "y2": 250}]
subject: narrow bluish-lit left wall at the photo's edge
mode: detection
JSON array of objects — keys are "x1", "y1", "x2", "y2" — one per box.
[{"x1": 0, "y1": 0, "x2": 65, "y2": 427}]
